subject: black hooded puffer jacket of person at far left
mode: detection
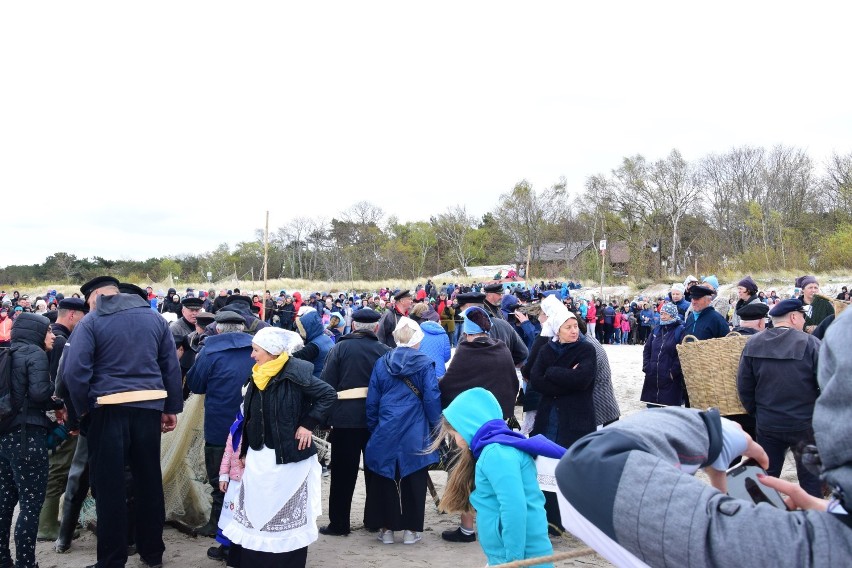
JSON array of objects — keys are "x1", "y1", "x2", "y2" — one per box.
[{"x1": 7, "y1": 313, "x2": 54, "y2": 430}]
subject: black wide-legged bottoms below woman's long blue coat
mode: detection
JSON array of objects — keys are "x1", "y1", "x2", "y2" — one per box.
[{"x1": 362, "y1": 466, "x2": 429, "y2": 532}]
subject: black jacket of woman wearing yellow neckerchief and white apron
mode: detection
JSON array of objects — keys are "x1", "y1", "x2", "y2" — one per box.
[{"x1": 241, "y1": 357, "x2": 336, "y2": 464}]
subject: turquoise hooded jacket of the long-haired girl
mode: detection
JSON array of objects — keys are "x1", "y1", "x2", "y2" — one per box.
[{"x1": 444, "y1": 387, "x2": 553, "y2": 566}]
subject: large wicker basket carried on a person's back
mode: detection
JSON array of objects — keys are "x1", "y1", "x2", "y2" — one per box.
[{"x1": 677, "y1": 333, "x2": 748, "y2": 416}]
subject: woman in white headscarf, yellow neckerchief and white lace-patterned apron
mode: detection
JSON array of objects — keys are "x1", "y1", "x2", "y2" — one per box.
[{"x1": 223, "y1": 327, "x2": 337, "y2": 568}]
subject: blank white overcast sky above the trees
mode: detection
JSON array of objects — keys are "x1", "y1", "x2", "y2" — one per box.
[{"x1": 0, "y1": 0, "x2": 852, "y2": 266}]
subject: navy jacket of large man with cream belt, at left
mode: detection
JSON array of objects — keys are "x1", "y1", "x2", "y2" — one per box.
[{"x1": 61, "y1": 294, "x2": 183, "y2": 415}]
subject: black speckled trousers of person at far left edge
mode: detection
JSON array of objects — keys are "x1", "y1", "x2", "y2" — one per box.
[{"x1": 0, "y1": 424, "x2": 47, "y2": 568}]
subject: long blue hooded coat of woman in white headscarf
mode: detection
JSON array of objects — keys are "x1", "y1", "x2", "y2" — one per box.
[{"x1": 364, "y1": 347, "x2": 441, "y2": 479}]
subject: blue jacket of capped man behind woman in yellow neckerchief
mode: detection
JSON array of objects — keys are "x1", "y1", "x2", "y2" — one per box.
[{"x1": 186, "y1": 333, "x2": 254, "y2": 446}]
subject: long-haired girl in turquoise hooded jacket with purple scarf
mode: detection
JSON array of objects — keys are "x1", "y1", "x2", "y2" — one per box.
[{"x1": 438, "y1": 387, "x2": 565, "y2": 566}]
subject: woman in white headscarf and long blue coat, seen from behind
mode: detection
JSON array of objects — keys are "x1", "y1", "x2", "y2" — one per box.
[{"x1": 364, "y1": 316, "x2": 441, "y2": 544}]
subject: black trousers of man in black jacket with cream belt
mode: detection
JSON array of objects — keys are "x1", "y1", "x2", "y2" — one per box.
[{"x1": 328, "y1": 428, "x2": 372, "y2": 532}]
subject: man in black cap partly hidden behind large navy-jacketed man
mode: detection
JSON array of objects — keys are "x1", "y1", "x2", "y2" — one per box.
[{"x1": 37, "y1": 298, "x2": 86, "y2": 541}]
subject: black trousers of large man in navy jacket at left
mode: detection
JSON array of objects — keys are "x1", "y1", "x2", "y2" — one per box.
[{"x1": 87, "y1": 405, "x2": 166, "y2": 568}]
